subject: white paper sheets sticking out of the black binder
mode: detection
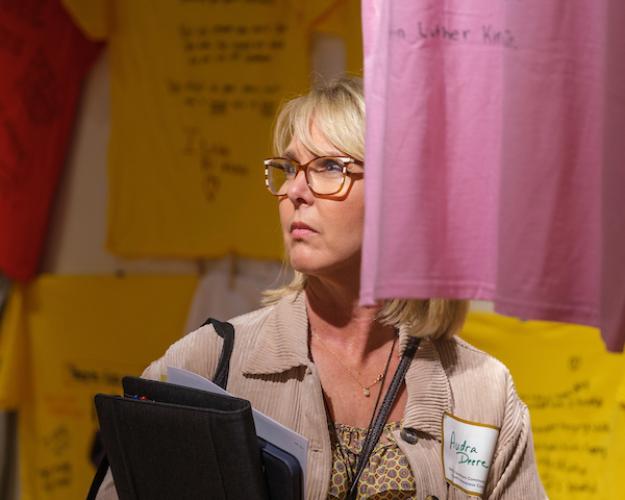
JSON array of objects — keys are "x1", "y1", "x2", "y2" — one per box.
[{"x1": 167, "y1": 366, "x2": 308, "y2": 491}]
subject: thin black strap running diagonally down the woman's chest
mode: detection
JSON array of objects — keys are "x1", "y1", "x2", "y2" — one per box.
[{"x1": 345, "y1": 337, "x2": 421, "y2": 500}]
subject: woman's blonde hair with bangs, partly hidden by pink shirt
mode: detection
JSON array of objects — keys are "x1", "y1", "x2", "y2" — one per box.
[{"x1": 263, "y1": 77, "x2": 469, "y2": 338}]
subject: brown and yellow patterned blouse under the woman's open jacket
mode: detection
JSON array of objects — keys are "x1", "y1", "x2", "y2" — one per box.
[{"x1": 328, "y1": 422, "x2": 416, "y2": 500}]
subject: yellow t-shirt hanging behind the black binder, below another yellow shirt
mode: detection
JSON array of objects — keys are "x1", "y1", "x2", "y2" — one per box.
[{"x1": 0, "y1": 275, "x2": 197, "y2": 500}]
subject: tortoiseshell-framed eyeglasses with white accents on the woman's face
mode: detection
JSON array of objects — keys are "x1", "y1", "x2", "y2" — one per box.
[{"x1": 264, "y1": 156, "x2": 363, "y2": 199}]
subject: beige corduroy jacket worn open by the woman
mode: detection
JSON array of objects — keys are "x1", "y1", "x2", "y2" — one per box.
[{"x1": 98, "y1": 293, "x2": 546, "y2": 500}]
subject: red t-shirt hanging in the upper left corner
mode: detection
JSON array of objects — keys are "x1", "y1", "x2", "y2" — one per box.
[{"x1": 0, "y1": 0, "x2": 99, "y2": 280}]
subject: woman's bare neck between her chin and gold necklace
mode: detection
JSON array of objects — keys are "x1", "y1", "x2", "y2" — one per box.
[{"x1": 306, "y1": 277, "x2": 395, "y2": 364}]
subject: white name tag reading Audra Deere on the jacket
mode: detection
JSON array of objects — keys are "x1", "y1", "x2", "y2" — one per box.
[{"x1": 442, "y1": 413, "x2": 499, "y2": 497}]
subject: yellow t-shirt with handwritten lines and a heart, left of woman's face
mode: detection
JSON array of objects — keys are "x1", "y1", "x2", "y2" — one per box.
[{"x1": 64, "y1": 0, "x2": 352, "y2": 259}]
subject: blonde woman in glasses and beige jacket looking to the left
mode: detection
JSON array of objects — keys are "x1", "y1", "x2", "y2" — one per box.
[{"x1": 99, "y1": 78, "x2": 545, "y2": 499}]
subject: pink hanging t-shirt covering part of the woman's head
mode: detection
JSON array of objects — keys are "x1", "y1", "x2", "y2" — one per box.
[{"x1": 361, "y1": 0, "x2": 625, "y2": 350}]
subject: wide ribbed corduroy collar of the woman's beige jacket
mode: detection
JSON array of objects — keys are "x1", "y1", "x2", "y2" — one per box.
[{"x1": 242, "y1": 292, "x2": 451, "y2": 441}]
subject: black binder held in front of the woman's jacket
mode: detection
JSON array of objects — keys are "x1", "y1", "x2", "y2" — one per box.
[{"x1": 95, "y1": 377, "x2": 302, "y2": 500}]
